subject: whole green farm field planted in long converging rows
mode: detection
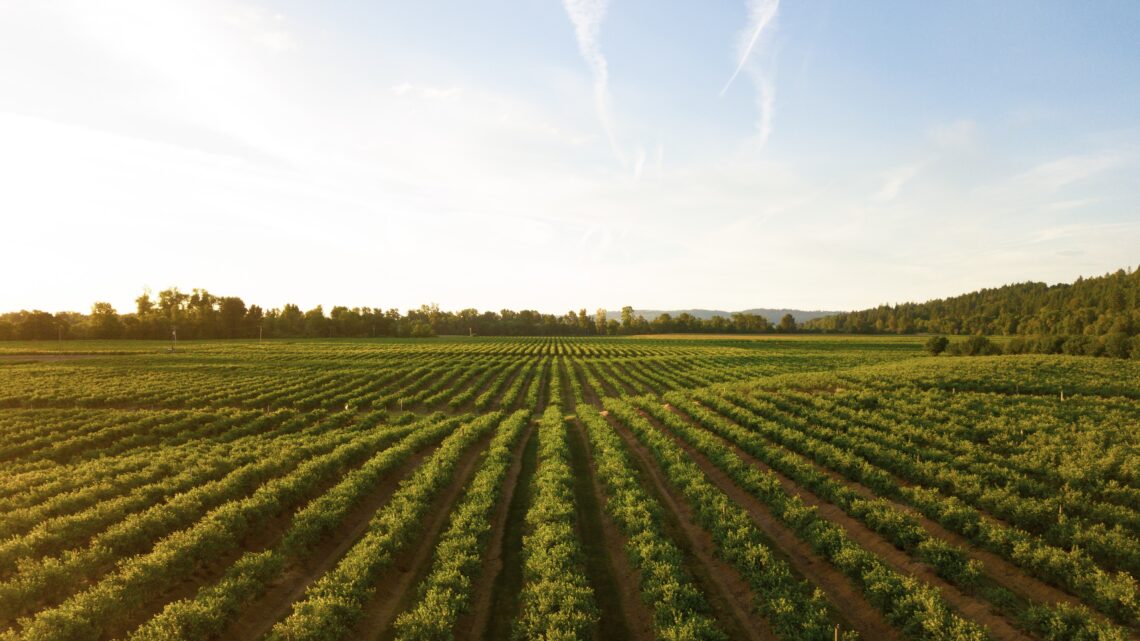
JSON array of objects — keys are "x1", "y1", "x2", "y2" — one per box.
[{"x1": 0, "y1": 335, "x2": 1140, "y2": 641}]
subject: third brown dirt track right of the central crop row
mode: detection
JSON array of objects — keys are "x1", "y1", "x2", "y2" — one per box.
[{"x1": 642, "y1": 406, "x2": 902, "y2": 641}]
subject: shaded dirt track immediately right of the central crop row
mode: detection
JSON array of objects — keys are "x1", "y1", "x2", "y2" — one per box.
[{"x1": 568, "y1": 419, "x2": 653, "y2": 641}]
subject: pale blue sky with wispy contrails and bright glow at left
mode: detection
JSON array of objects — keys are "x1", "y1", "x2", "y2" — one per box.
[{"x1": 0, "y1": 0, "x2": 1140, "y2": 313}]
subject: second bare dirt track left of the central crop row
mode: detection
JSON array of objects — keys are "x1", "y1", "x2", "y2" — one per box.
[{"x1": 351, "y1": 426, "x2": 492, "y2": 640}]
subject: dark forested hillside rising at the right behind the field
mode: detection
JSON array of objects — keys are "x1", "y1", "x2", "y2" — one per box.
[{"x1": 806, "y1": 269, "x2": 1140, "y2": 335}]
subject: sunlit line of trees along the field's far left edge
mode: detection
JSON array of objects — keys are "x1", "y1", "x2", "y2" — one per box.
[{"x1": 0, "y1": 287, "x2": 798, "y2": 340}]
